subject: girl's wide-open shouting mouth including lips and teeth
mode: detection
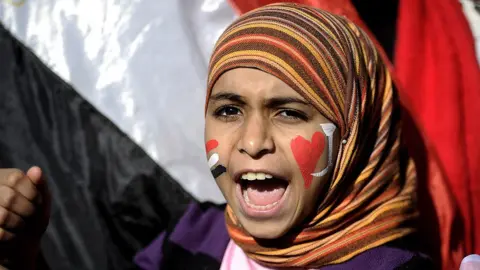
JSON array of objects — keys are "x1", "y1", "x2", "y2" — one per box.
[{"x1": 237, "y1": 172, "x2": 289, "y2": 215}]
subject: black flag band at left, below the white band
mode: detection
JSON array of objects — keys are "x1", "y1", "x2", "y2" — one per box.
[{"x1": 0, "y1": 26, "x2": 193, "y2": 270}]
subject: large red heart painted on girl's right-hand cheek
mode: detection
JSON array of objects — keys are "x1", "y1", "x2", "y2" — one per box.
[{"x1": 290, "y1": 132, "x2": 325, "y2": 188}]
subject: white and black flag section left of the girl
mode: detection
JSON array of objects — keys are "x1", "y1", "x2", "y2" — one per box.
[{"x1": 0, "y1": 0, "x2": 236, "y2": 270}]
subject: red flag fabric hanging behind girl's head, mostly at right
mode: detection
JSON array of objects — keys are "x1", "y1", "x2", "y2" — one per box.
[{"x1": 230, "y1": 0, "x2": 480, "y2": 269}]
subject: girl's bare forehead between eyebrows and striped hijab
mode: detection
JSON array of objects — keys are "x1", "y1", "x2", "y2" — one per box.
[{"x1": 212, "y1": 68, "x2": 303, "y2": 99}]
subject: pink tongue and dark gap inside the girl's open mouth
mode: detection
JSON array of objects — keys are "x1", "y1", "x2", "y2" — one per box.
[{"x1": 244, "y1": 179, "x2": 286, "y2": 206}]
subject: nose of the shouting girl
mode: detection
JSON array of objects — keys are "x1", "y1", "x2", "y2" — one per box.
[{"x1": 237, "y1": 113, "x2": 275, "y2": 159}]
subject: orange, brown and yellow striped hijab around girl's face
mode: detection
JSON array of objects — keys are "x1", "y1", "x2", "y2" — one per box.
[{"x1": 207, "y1": 4, "x2": 417, "y2": 267}]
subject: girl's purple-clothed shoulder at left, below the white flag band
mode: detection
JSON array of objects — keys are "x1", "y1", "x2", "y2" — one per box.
[{"x1": 135, "y1": 203, "x2": 230, "y2": 270}]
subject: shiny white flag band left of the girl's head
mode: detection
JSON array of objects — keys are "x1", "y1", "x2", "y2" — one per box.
[{"x1": 0, "y1": 0, "x2": 236, "y2": 202}]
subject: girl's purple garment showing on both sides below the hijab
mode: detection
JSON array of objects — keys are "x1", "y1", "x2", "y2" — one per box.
[{"x1": 135, "y1": 203, "x2": 419, "y2": 270}]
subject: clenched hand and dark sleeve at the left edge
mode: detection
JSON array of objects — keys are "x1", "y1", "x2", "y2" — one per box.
[{"x1": 0, "y1": 167, "x2": 51, "y2": 269}]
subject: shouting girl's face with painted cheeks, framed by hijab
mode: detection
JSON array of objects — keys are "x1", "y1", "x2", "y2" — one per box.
[{"x1": 205, "y1": 68, "x2": 339, "y2": 239}]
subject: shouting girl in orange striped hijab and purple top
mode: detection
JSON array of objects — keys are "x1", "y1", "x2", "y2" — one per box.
[{"x1": 0, "y1": 4, "x2": 436, "y2": 269}]
